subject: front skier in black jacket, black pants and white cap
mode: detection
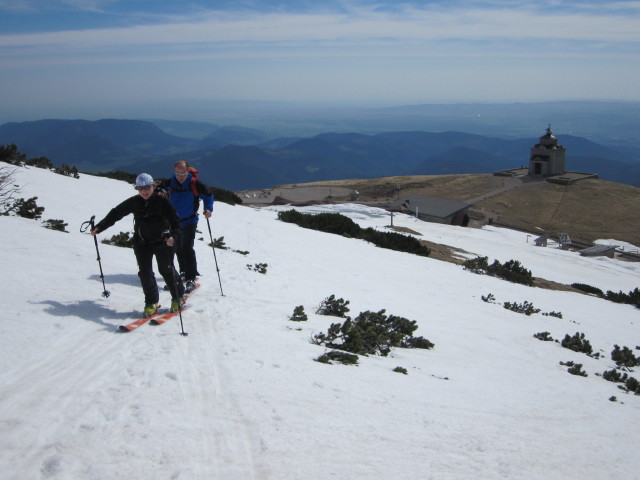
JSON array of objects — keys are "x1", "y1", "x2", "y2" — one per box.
[{"x1": 91, "y1": 173, "x2": 184, "y2": 316}]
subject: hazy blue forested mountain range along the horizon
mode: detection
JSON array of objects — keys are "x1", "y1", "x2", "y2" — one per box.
[{"x1": 0, "y1": 120, "x2": 640, "y2": 191}]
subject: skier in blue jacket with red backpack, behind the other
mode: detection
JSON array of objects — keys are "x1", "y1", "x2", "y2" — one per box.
[{"x1": 162, "y1": 160, "x2": 213, "y2": 292}]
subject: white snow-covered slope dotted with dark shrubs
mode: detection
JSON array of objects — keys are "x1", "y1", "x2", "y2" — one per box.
[{"x1": 0, "y1": 164, "x2": 640, "y2": 480}]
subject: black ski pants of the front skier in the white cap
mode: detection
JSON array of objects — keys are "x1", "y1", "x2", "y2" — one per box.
[{"x1": 133, "y1": 242, "x2": 184, "y2": 304}]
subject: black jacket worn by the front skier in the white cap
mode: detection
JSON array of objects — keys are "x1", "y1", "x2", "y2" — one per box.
[{"x1": 96, "y1": 192, "x2": 180, "y2": 244}]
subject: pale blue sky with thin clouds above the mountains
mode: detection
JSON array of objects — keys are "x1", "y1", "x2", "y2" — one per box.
[{"x1": 0, "y1": 0, "x2": 640, "y2": 117}]
